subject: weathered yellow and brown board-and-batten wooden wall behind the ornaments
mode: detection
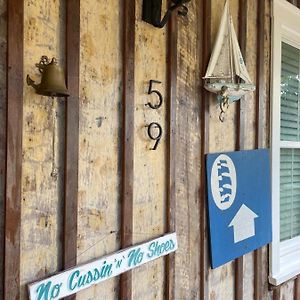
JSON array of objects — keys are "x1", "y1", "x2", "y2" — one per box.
[{"x1": 0, "y1": 0, "x2": 300, "y2": 300}]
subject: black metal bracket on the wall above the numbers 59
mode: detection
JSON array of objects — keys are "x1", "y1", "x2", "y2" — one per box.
[{"x1": 142, "y1": 0, "x2": 191, "y2": 28}]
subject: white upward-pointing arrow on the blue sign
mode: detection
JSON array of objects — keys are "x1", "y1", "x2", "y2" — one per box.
[{"x1": 228, "y1": 204, "x2": 258, "y2": 244}]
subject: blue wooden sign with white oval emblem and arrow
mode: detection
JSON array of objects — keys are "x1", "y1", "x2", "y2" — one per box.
[{"x1": 206, "y1": 149, "x2": 272, "y2": 268}]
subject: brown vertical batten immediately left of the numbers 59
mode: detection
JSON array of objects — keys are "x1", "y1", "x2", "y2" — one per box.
[{"x1": 120, "y1": 0, "x2": 136, "y2": 300}]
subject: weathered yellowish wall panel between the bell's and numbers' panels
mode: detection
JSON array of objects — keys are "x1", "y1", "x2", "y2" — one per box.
[{"x1": 77, "y1": 0, "x2": 123, "y2": 300}]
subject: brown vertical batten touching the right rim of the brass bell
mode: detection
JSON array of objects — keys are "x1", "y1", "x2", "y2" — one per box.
[{"x1": 63, "y1": 0, "x2": 80, "y2": 292}]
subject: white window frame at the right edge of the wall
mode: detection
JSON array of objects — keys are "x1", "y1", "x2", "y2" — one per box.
[{"x1": 269, "y1": 0, "x2": 300, "y2": 285}]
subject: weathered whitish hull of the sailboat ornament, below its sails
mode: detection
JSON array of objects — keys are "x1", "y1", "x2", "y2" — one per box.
[{"x1": 204, "y1": 82, "x2": 255, "y2": 102}]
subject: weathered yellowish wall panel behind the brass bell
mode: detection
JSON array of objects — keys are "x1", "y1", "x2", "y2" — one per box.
[{"x1": 20, "y1": 0, "x2": 65, "y2": 298}]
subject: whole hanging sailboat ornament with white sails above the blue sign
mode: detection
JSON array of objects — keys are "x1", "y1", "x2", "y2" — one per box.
[{"x1": 203, "y1": 0, "x2": 255, "y2": 122}]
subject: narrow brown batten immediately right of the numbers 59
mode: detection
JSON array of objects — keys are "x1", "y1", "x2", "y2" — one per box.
[{"x1": 166, "y1": 10, "x2": 178, "y2": 299}]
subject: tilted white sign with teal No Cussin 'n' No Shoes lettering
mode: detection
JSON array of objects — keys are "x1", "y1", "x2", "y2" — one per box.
[{"x1": 28, "y1": 233, "x2": 178, "y2": 300}]
